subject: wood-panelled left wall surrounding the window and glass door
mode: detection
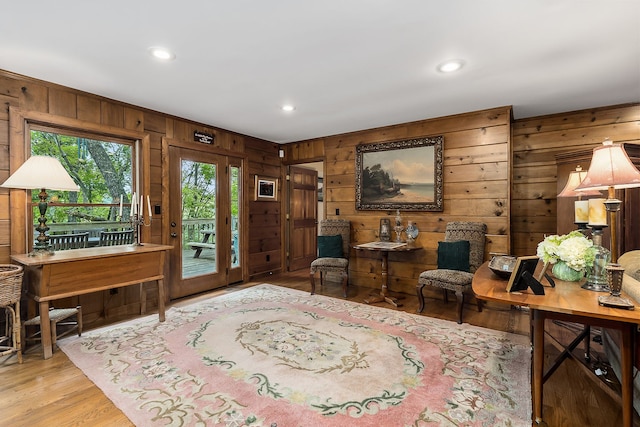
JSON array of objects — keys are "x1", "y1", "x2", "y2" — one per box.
[{"x1": 0, "y1": 70, "x2": 281, "y2": 318}]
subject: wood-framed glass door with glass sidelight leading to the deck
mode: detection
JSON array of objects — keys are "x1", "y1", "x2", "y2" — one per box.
[{"x1": 168, "y1": 146, "x2": 243, "y2": 299}]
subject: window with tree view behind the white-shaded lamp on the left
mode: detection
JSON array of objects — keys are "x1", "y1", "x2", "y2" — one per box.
[{"x1": 30, "y1": 128, "x2": 135, "y2": 241}]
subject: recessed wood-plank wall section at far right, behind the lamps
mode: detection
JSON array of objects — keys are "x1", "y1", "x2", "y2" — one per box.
[{"x1": 511, "y1": 104, "x2": 640, "y2": 255}]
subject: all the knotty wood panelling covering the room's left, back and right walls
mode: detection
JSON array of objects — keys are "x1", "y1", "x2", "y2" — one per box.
[{"x1": 0, "y1": 70, "x2": 640, "y2": 320}]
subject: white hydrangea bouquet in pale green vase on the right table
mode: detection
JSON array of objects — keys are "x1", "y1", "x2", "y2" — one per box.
[{"x1": 537, "y1": 230, "x2": 597, "y2": 282}]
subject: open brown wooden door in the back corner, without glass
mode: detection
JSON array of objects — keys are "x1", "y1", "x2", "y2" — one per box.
[{"x1": 288, "y1": 166, "x2": 318, "y2": 271}]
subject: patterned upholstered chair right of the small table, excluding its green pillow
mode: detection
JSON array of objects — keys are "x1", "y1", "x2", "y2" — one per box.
[{"x1": 417, "y1": 222, "x2": 487, "y2": 323}]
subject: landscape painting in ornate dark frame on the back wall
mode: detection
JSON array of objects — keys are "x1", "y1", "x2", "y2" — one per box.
[{"x1": 356, "y1": 136, "x2": 444, "y2": 211}]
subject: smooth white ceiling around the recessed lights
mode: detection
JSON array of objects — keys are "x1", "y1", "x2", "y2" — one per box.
[{"x1": 0, "y1": 0, "x2": 640, "y2": 142}]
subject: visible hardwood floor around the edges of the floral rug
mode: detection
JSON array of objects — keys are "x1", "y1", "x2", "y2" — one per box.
[{"x1": 0, "y1": 271, "x2": 640, "y2": 427}]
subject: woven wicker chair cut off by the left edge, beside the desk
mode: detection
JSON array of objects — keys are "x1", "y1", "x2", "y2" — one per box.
[{"x1": 0, "y1": 264, "x2": 24, "y2": 363}]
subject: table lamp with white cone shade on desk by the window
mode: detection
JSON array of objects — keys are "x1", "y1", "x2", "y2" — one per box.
[{"x1": 0, "y1": 156, "x2": 80, "y2": 255}]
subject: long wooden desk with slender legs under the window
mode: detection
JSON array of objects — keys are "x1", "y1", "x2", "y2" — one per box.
[{"x1": 11, "y1": 243, "x2": 173, "y2": 359}]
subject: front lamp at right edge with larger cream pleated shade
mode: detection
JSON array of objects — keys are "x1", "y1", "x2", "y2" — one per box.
[{"x1": 576, "y1": 139, "x2": 640, "y2": 263}]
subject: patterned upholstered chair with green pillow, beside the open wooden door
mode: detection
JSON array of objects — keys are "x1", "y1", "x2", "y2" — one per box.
[{"x1": 310, "y1": 219, "x2": 351, "y2": 298}]
